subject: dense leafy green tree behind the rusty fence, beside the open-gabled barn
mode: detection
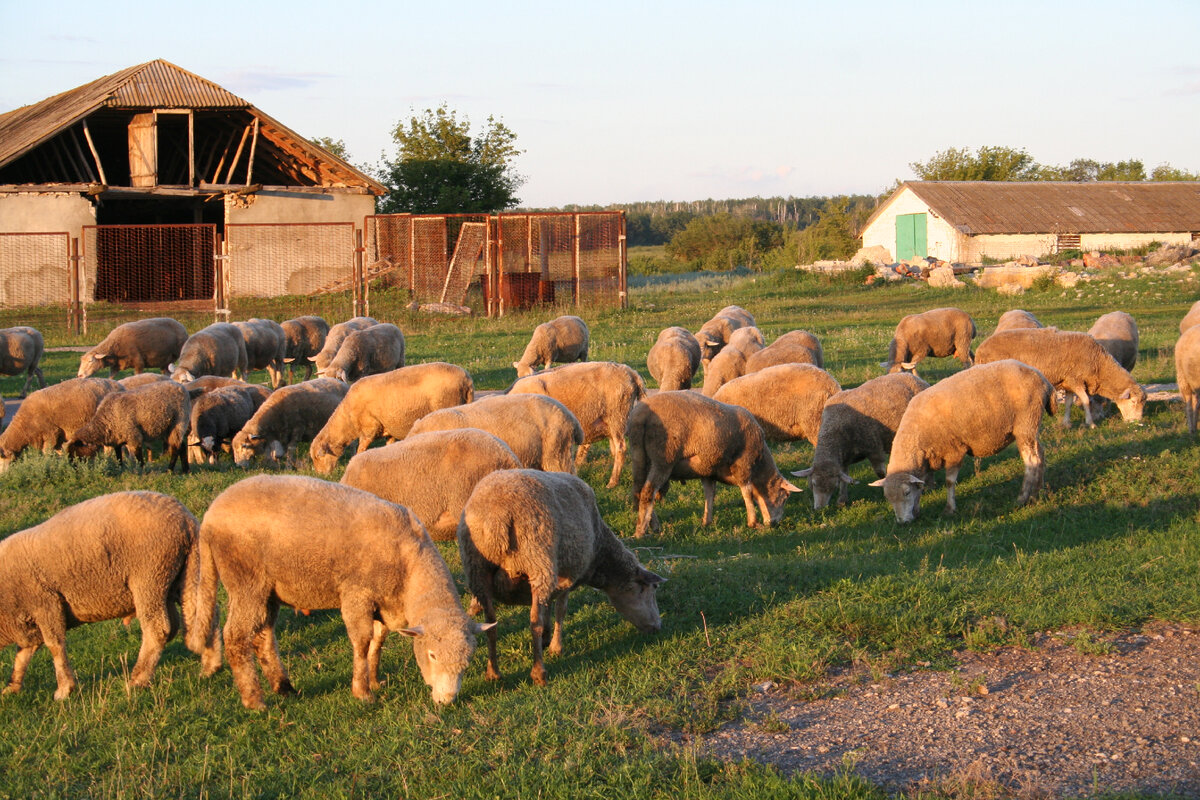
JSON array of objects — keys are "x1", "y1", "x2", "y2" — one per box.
[{"x1": 379, "y1": 103, "x2": 524, "y2": 213}]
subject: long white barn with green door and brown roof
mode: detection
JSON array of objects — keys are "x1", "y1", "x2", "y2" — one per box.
[{"x1": 862, "y1": 181, "x2": 1200, "y2": 264}]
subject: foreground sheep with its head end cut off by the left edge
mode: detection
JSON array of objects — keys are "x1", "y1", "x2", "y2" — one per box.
[{"x1": 0, "y1": 492, "x2": 221, "y2": 700}]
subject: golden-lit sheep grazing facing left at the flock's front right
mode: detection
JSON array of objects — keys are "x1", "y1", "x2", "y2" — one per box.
[{"x1": 871, "y1": 359, "x2": 1054, "y2": 523}]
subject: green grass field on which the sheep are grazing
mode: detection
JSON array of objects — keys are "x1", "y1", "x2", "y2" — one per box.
[{"x1": 0, "y1": 266, "x2": 1200, "y2": 799}]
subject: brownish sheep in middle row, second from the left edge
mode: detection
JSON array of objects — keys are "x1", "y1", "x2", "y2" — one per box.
[{"x1": 67, "y1": 379, "x2": 192, "y2": 474}]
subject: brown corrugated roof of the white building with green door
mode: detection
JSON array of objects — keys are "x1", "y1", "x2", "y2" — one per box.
[{"x1": 888, "y1": 181, "x2": 1200, "y2": 235}]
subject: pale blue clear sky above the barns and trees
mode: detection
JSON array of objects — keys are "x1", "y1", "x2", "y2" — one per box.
[{"x1": 0, "y1": 0, "x2": 1200, "y2": 207}]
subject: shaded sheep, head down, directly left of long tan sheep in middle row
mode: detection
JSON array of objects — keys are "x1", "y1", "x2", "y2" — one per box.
[{"x1": 233, "y1": 378, "x2": 348, "y2": 469}]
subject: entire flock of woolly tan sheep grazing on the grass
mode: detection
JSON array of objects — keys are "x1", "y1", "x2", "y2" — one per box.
[{"x1": 0, "y1": 297, "x2": 1200, "y2": 709}]
